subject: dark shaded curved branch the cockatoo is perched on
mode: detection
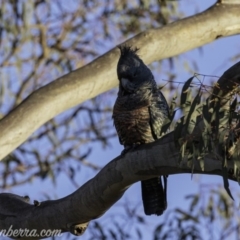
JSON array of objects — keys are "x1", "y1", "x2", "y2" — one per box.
[{"x1": 0, "y1": 133, "x2": 235, "y2": 239}]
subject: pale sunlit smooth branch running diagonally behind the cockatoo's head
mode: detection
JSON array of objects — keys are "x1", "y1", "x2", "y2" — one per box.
[{"x1": 0, "y1": 3, "x2": 240, "y2": 159}]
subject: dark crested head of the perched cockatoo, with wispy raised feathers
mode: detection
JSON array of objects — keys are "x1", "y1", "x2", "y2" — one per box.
[{"x1": 117, "y1": 46, "x2": 155, "y2": 93}]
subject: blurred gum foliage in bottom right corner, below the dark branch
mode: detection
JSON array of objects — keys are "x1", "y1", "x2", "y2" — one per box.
[{"x1": 153, "y1": 185, "x2": 240, "y2": 240}]
